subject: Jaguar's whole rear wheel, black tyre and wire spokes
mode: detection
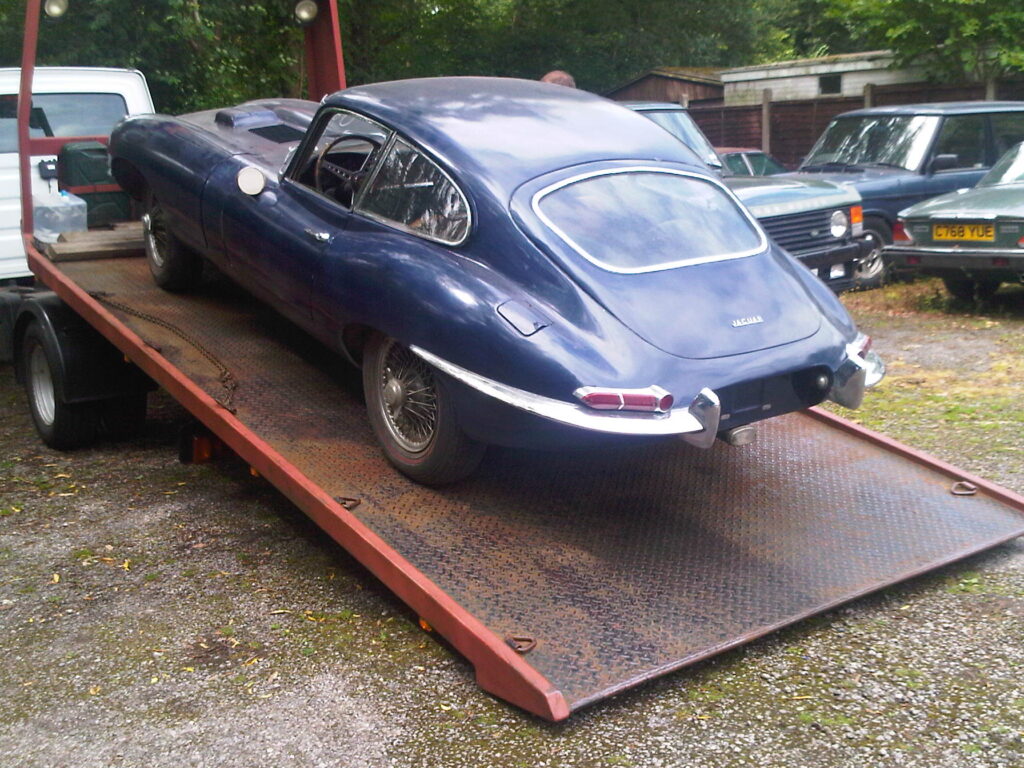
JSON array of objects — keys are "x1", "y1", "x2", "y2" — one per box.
[{"x1": 362, "y1": 335, "x2": 486, "y2": 485}]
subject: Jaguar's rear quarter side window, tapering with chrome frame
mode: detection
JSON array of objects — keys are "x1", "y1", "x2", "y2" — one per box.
[{"x1": 355, "y1": 138, "x2": 469, "y2": 245}]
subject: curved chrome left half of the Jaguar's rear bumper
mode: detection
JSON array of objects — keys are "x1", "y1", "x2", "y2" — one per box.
[{"x1": 410, "y1": 346, "x2": 718, "y2": 436}]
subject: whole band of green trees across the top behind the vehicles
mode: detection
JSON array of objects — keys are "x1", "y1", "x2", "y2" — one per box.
[{"x1": 12, "y1": 0, "x2": 1024, "y2": 113}]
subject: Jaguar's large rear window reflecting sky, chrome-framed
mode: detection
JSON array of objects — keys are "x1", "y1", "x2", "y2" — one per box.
[{"x1": 534, "y1": 168, "x2": 767, "y2": 273}]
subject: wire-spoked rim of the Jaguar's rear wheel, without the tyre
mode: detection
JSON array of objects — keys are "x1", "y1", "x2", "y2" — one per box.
[{"x1": 377, "y1": 341, "x2": 437, "y2": 454}]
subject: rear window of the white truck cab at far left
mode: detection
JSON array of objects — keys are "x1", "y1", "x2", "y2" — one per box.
[{"x1": 0, "y1": 93, "x2": 128, "y2": 153}]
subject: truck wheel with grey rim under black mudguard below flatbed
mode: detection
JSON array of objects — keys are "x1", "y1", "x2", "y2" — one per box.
[{"x1": 22, "y1": 323, "x2": 99, "y2": 451}]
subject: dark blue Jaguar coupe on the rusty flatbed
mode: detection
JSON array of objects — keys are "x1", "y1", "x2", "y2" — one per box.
[{"x1": 111, "y1": 78, "x2": 883, "y2": 483}]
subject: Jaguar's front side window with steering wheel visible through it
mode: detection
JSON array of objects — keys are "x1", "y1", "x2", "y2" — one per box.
[{"x1": 291, "y1": 110, "x2": 391, "y2": 208}]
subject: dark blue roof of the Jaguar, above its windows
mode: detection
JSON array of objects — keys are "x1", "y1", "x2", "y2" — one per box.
[{"x1": 325, "y1": 77, "x2": 707, "y2": 195}]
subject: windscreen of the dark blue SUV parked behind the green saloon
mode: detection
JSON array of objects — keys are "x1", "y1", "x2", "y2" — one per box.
[{"x1": 800, "y1": 115, "x2": 939, "y2": 171}]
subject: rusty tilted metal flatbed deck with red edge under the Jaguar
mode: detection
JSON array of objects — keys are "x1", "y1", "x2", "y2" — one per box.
[{"x1": 29, "y1": 252, "x2": 1024, "y2": 720}]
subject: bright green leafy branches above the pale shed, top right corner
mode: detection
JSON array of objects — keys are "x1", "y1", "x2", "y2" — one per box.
[{"x1": 830, "y1": 0, "x2": 1024, "y2": 98}]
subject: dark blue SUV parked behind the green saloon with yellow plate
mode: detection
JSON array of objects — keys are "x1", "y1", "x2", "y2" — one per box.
[{"x1": 786, "y1": 101, "x2": 1024, "y2": 287}]
